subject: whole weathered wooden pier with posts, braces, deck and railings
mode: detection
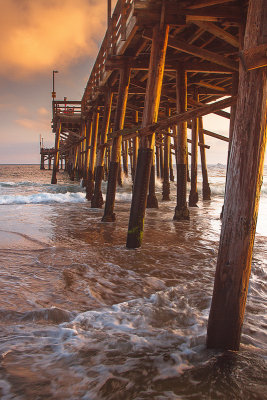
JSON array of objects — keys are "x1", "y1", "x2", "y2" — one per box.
[{"x1": 48, "y1": 0, "x2": 267, "y2": 350}]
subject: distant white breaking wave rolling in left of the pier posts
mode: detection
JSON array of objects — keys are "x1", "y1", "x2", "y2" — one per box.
[{"x1": 0, "y1": 192, "x2": 87, "y2": 205}]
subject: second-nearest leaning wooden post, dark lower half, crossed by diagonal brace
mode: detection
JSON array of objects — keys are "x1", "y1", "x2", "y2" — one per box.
[{"x1": 126, "y1": 25, "x2": 169, "y2": 248}]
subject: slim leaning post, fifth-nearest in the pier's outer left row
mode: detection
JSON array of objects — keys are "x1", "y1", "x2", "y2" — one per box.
[{"x1": 86, "y1": 107, "x2": 99, "y2": 200}]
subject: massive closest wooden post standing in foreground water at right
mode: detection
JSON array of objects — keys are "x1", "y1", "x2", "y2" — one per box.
[{"x1": 207, "y1": 0, "x2": 267, "y2": 350}]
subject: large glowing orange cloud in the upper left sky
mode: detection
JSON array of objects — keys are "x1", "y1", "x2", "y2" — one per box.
[{"x1": 0, "y1": 0, "x2": 106, "y2": 78}]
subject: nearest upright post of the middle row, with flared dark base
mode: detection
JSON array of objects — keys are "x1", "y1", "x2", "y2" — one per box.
[{"x1": 173, "y1": 67, "x2": 189, "y2": 221}]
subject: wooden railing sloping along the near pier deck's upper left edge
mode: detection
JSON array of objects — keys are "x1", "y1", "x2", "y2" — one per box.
[{"x1": 82, "y1": 0, "x2": 134, "y2": 113}]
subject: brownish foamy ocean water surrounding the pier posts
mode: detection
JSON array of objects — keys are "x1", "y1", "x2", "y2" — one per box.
[{"x1": 0, "y1": 164, "x2": 267, "y2": 400}]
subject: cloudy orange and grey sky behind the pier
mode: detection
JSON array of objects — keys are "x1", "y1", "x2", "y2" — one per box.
[{"x1": 0, "y1": 0, "x2": 253, "y2": 163}]
